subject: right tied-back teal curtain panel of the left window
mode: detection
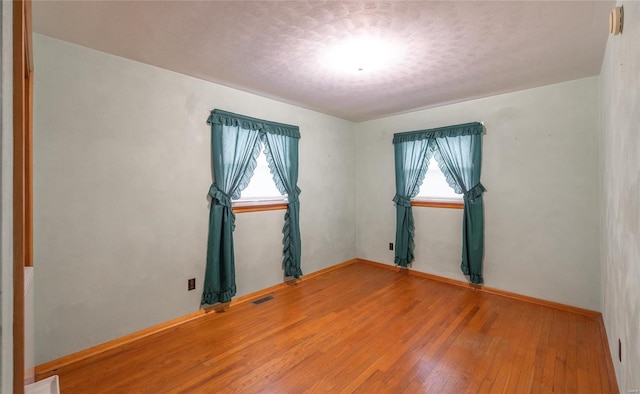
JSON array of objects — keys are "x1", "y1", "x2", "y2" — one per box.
[{"x1": 262, "y1": 132, "x2": 302, "y2": 278}]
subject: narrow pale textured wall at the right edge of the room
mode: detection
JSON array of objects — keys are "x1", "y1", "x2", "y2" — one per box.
[{"x1": 600, "y1": 1, "x2": 640, "y2": 393}]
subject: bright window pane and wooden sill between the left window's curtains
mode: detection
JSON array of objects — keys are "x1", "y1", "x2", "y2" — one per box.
[{"x1": 233, "y1": 148, "x2": 287, "y2": 213}]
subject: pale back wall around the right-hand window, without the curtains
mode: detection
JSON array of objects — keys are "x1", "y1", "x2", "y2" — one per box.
[{"x1": 356, "y1": 77, "x2": 600, "y2": 310}]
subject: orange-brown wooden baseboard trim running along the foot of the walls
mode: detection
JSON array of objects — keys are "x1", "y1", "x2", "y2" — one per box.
[{"x1": 35, "y1": 258, "x2": 600, "y2": 378}]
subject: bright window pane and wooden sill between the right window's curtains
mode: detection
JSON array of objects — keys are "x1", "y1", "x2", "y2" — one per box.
[{"x1": 411, "y1": 157, "x2": 464, "y2": 208}]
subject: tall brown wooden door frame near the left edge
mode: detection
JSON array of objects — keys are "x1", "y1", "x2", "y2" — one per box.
[{"x1": 13, "y1": 0, "x2": 33, "y2": 394}]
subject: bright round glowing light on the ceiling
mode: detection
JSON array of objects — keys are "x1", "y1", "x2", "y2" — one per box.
[{"x1": 325, "y1": 36, "x2": 403, "y2": 74}]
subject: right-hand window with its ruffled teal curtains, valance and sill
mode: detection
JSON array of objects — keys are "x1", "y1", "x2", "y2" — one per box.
[{"x1": 393, "y1": 122, "x2": 486, "y2": 284}]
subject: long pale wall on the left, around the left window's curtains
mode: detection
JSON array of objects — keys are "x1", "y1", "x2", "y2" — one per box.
[{"x1": 34, "y1": 35, "x2": 355, "y2": 364}]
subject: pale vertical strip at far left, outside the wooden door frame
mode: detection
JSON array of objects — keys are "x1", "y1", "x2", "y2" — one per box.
[{"x1": 0, "y1": 1, "x2": 13, "y2": 393}]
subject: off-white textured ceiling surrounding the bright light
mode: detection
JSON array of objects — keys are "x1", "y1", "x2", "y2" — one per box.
[{"x1": 33, "y1": 1, "x2": 615, "y2": 121}]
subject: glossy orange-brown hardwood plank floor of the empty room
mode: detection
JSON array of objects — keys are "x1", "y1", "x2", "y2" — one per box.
[{"x1": 38, "y1": 263, "x2": 616, "y2": 394}]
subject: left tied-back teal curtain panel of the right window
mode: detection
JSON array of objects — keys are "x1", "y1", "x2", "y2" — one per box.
[{"x1": 393, "y1": 139, "x2": 430, "y2": 267}]
